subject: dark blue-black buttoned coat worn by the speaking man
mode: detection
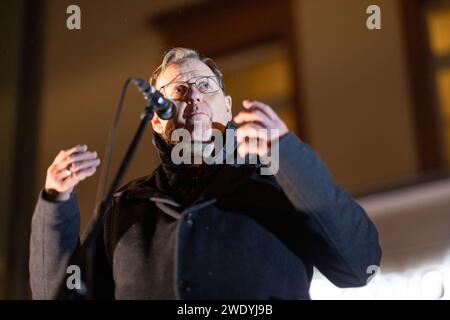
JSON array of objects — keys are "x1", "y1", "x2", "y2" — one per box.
[{"x1": 30, "y1": 133, "x2": 381, "y2": 299}]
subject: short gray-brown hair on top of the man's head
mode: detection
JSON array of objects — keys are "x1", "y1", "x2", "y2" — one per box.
[{"x1": 150, "y1": 47, "x2": 226, "y2": 94}]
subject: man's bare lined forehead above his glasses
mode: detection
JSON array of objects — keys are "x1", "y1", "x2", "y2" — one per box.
[{"x1": 157, "y1": 59, "x2": 214, "y2": 87}]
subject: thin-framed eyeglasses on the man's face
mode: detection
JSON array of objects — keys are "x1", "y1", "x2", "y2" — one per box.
[{"x1": 160, "y1": 76, "x2": 220, "y2": 100}]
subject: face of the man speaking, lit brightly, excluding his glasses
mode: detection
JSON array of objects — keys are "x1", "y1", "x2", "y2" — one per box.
[{"x1": 152, "y1": 59, "x2": 232, "y2": 142}]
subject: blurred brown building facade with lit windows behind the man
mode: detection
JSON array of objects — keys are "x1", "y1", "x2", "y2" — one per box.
[{"x1": 0, "y1": 0, "x2": 450, "y2": 298}]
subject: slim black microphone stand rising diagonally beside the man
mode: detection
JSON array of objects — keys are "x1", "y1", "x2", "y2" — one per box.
[{"x1": 56, "y1": 99, "x2": 156, "y2": 300}]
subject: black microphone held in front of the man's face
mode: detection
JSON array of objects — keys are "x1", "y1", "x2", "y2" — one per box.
[{"x1": 132, "y1": 78, "x2": 178, "y2": 120}]
